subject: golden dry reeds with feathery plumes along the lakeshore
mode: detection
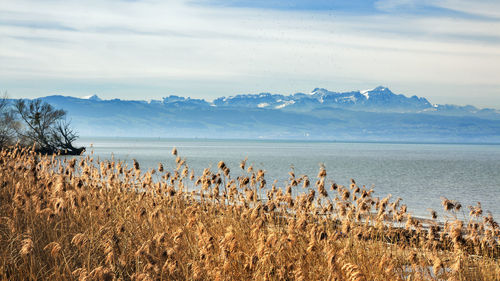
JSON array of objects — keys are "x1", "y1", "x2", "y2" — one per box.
[{"x1": 0, "y1": 145, "x2": 500, "y2": 280}]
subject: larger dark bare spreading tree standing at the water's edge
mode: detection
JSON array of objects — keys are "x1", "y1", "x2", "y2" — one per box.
[{"x1": 14, "y1": 99, "x2": 84, "y2": 154}]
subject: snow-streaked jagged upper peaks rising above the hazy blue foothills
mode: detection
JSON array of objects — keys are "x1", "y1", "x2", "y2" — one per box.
[{"x1": 44, "y1": 86, "x2": 500, "y2": 119}]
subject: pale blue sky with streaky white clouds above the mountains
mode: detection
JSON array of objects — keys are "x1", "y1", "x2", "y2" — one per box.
[{"x1": 0, "y1": 0, "x2": 500, "y2": 108}]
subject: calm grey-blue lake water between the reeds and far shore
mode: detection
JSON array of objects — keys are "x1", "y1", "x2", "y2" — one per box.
[{"x1": 75, "y1": 138, "x2": 500, "y2": 219}]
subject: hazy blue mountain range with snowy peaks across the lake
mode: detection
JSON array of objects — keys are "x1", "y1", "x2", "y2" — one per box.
[{"x1": 24, "y1": 86, "x2": 500, "y2": 143}]
